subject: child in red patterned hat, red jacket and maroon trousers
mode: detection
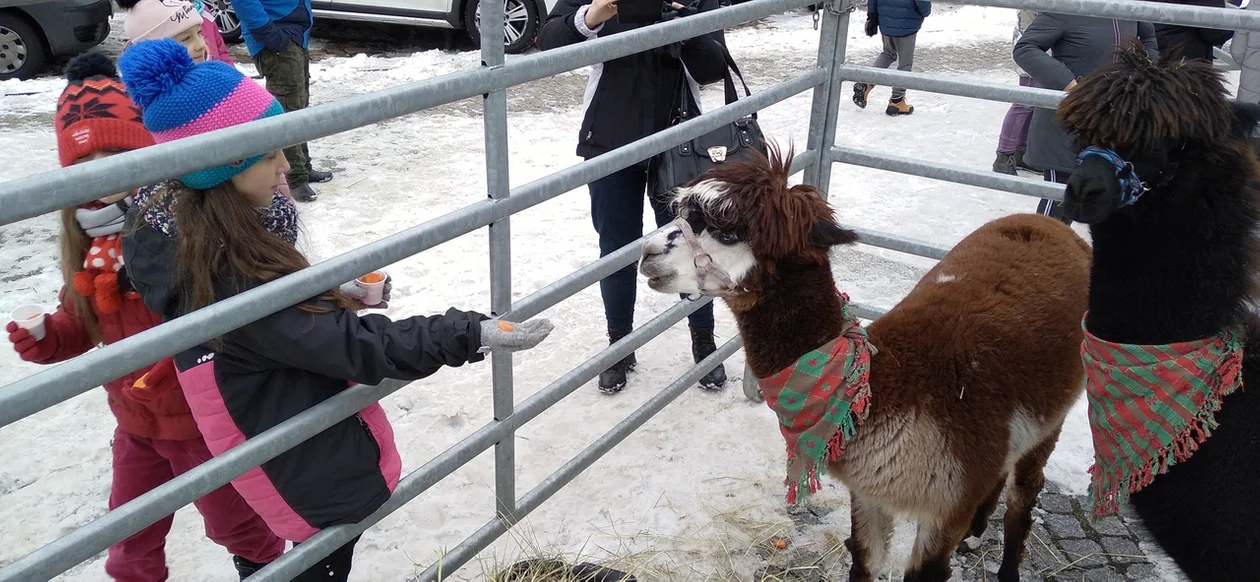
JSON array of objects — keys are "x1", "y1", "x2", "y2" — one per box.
[{"x1": 6, "y1": 53, "x2": 285, "y2": 582}]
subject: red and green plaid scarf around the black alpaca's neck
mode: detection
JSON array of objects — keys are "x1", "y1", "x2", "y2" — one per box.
[{"x1": 1081, "y1": 314, "x2": 1244, "y2": 519}]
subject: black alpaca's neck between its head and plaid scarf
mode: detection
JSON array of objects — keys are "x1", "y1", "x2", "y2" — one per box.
[{"x1": 1087, "y1": 164, "x2": 1256, "y2": 344}]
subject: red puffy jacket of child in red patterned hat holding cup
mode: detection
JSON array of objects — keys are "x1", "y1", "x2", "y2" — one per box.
[{"x1": 24, "y1": 278, "x2": 202, "y2": 441}]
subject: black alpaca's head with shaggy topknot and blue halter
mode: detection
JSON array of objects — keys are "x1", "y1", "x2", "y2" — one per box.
[{"x1": 1058, "y1": 44, "x2": 1257, "y2": 224}]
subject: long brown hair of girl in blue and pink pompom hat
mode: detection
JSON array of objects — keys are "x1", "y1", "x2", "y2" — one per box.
[{"x1": 152, "y1": 181, "x2": 353, "y2": 312}]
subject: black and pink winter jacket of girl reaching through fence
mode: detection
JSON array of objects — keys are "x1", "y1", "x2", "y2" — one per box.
[{"x1": 123, "y1": 191, "x2": 486, "y2": 542}]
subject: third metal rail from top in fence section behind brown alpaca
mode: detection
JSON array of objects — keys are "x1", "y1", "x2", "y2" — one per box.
[{"x1": 829, "y1": 146, "x2": 1063, "y2": 202}]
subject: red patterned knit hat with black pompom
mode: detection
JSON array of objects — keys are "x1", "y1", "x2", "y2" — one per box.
[{"x1": 53, "y1": 52, "x2": 154, "y2": 168}]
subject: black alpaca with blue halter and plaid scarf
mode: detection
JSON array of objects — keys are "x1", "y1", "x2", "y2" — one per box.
[{"x1": 1058, "y1": 43, "x2": 1260, "y2": 581}]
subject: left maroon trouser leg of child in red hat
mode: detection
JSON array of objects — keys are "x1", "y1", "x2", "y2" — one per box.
[{"x1": 105, "y1": 428, "x2": 175, "y2": 582}]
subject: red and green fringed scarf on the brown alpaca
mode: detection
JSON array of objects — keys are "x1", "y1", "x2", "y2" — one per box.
[{"x1": 757, "y1": 294, "x2": 877, "y2": 505}]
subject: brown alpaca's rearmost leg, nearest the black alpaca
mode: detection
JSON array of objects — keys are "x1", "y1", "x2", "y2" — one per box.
[{"x1": 998, "y1": 428, "x2": 1061, "y2": 582}]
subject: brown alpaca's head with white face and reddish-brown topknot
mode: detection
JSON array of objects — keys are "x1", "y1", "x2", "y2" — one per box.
[{"x1": 639, "y1": 147, "x2": 857, "y2": 302}]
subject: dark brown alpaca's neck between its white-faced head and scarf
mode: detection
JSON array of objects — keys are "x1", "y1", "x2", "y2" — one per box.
[{"x1": 735, "y1": 265, "x2": 845, "y2": 378}]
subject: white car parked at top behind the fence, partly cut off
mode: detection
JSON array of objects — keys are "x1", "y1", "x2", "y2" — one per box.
[{"x1": 204, "y1": 0, "x2": 557, "y2": 53}]
